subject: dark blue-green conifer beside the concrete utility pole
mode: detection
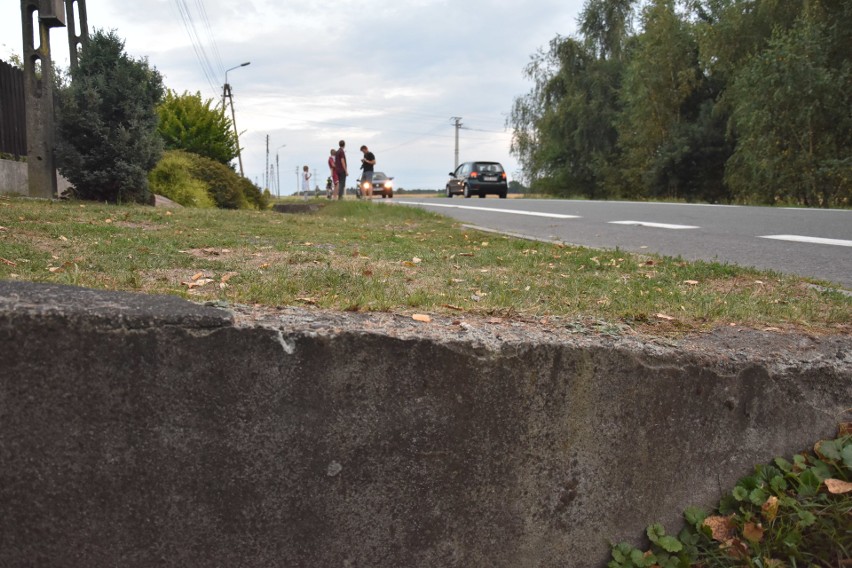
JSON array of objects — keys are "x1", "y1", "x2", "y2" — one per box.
[{"x1": 57, "y1": 30, "x2": 163, "y2": 202}]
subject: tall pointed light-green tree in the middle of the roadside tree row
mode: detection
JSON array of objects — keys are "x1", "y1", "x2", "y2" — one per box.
[{"x1": 618, "y1": 0, "x2": 730, "y2": 201}]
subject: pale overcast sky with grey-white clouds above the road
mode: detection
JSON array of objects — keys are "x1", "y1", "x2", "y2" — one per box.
[{"x1": 0, "y1": 0, "x2": 583, "y2": 195}]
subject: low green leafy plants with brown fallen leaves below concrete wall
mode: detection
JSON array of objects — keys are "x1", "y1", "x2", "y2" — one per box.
[{"x1": 608, "y1": 424, "x2": 852, "y2": 568}]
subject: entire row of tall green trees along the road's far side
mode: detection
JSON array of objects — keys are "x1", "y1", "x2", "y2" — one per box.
[{"x1": 507, "y1": 0, "x2": 852, "y2": 207}]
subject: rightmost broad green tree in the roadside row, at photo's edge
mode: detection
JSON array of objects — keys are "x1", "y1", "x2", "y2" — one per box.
[{"x1": 727, "y1": 14, "x2": 852, "y2": 207}]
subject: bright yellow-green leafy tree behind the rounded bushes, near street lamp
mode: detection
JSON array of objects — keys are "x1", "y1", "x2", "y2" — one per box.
[{"x1": 157, "y1": 90, "x2": 237, "y2": 164}]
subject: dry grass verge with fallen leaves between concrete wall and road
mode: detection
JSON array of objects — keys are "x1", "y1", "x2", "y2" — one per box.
[{"x1": 0, "y1": 197, "x2": 852, "y2": 333}]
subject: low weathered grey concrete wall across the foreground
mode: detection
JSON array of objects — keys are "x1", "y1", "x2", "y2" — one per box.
[{"x1": 0, "y1": 282, "x2": 852, "y2": 567}]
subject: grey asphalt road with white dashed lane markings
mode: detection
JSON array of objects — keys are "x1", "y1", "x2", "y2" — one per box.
[{"x1": 394, "y1": 198, "x2": 852, "y2": 290}]
